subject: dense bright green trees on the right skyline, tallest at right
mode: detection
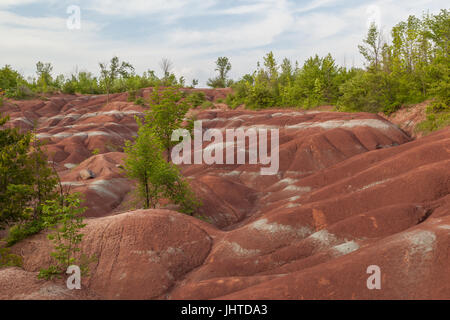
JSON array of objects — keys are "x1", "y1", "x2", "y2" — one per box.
[{"x1": 226, "y1": 10, "x2": 450, "y2": 119}]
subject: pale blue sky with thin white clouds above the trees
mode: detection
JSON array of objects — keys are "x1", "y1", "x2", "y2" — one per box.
[{"x1": 0, "y1": 0, "x2": 448, "y2": 86}]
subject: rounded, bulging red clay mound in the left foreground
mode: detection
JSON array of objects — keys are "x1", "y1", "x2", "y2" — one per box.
[{"x1": 9, "y1": 210, "x2": 211, "y2": 299}]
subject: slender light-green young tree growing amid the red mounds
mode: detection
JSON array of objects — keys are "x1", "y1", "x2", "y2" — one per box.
[{"x1": 125, "y1": 87, "x2": 203, "y2": 214}]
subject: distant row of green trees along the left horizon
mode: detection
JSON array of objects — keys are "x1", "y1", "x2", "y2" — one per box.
[{"x1": 0, "y1": 57, "x2": 198, "y2": 99}]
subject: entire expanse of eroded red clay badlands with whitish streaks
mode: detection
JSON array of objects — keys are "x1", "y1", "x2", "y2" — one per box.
[{"x1": 0, "y1": 89, "x2": 450, "y2": 299}]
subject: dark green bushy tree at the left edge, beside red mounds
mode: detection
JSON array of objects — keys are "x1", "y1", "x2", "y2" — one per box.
[{"x1": 0, "y1": 117, "x2": 57, "y2": 245}]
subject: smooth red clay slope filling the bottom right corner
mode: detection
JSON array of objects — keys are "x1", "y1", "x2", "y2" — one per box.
[{"x1": 216, "y1": 215, "x2": 450, "y2": 299}]
